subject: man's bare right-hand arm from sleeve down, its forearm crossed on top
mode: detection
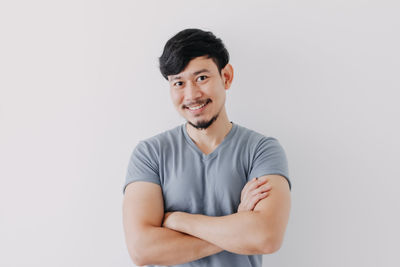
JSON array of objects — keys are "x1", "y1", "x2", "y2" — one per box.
[{"x1": 164, "y1": 175, "x2": 290, "y2": 254}]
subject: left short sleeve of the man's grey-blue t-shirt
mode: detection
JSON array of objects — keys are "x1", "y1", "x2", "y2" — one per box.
[{"x1": 123, "y1": 141, "x2": 161, "y2": 193}]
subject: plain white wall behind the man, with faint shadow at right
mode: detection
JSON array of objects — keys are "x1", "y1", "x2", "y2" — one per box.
[{"x1": 0, "y1": 0, "x2": 400, "y2": 267}]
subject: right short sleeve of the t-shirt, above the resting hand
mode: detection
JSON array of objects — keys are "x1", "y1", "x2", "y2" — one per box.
[{"x1": 248, "y1": 137, "x2": 292, "y2": 190}]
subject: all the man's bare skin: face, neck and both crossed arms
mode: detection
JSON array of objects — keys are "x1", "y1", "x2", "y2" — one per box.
[{"x1": 123, "y1": 57, "x2": 290, "y2": 265}]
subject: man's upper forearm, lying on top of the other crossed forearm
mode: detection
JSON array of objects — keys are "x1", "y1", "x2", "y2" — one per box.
[{"x1": 168, "y1": 211, "x2": 272, "y2": 254}]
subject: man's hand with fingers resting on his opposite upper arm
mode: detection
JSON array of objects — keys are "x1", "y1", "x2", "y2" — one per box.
[{"x1": 238, "y1": 177, "x2": 271, "y2": 212}]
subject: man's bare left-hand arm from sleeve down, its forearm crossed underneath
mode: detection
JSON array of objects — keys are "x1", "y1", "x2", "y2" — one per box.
[{"x1": 123, "y1": 182, "x2": 222, "y2": 265}]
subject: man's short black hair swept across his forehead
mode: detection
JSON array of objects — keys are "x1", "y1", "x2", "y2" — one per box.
[{"x1": 159, "y1": 29, "x2": 229, "y2": 80}]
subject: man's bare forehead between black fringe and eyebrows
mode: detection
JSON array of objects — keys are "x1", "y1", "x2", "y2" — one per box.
[{"x1": 168, "y1": 56, "x2": 218, "y2": 81}]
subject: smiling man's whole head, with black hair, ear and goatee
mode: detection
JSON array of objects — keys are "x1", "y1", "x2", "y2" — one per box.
[{"x1": 160, "y1": 29, "x2": 233, "y2": 129}]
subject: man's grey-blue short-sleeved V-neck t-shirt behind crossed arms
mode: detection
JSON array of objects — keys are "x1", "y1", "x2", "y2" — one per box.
[{"x1": 123, "y1": 123, "x2": 291, "y2": 267}]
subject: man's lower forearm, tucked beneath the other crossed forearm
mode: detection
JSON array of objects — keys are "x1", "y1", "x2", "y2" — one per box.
[{"x1": 127, "y1": 226, "x2": 222, "y2": 265}]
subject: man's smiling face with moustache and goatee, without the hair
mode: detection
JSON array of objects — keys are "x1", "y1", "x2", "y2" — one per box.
[{"x1": 168, "y1": 57, "x2": 230, "y2": 129}]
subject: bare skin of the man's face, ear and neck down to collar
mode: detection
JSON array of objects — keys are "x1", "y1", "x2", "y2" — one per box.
[{"x1": 168, "y1": 57, "x2": 233, "y2": 154}]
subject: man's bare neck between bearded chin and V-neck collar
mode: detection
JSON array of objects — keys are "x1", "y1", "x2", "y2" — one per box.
[{"x1": 186, "y1": 108, "x2": 232, "y2": 148}]
